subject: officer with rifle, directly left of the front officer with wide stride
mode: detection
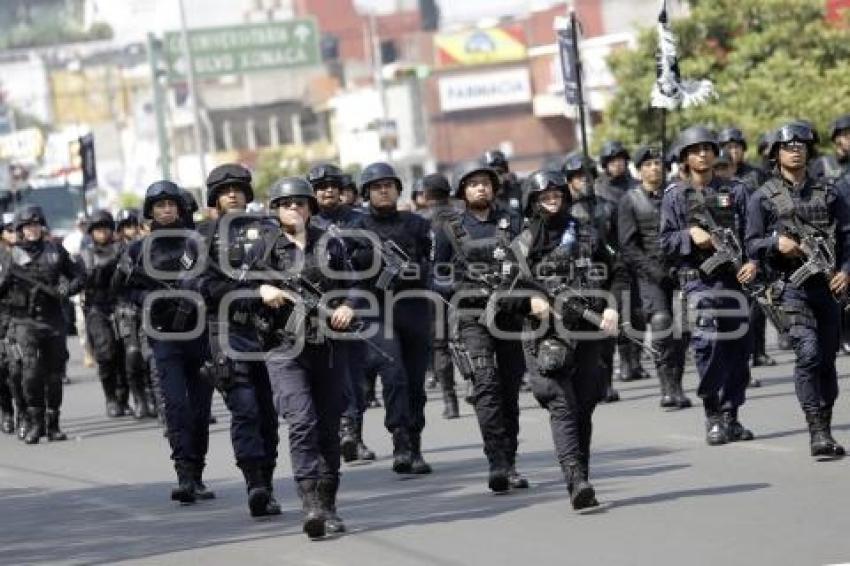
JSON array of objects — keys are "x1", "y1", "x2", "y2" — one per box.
[{"x1": 434, "y1": 161, "x2": 528, "y2": 493}]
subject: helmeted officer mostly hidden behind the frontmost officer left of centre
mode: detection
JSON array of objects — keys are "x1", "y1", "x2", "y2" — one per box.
[{"x1": 307, "y1": 164, "x2": 375, "y2": 462}]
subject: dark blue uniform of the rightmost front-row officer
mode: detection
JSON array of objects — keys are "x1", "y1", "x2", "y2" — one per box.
[{"x1": 747, "y1": 177, "x2": 850, "y2": 413}]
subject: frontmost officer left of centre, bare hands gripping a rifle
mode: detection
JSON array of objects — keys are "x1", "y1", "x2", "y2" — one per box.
[{"x1": 252, "y1": 179, "x2": 356, "y2": 538}]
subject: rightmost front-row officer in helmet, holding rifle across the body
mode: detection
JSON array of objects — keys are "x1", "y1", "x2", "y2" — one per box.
[{"x1": 747, "y1": 123, "x2": 850, "y2": 457}]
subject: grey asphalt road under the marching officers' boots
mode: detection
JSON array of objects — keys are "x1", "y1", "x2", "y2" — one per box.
[{"x1": 0, "y1": 340, "x2": 850, "y2": 566}]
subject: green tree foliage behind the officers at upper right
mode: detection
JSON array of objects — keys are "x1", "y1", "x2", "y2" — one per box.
[{"x1": 594, "y1": 0, "x2": 850, "y2": 158}]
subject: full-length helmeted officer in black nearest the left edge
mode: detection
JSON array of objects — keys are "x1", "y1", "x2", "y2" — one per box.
[{"x1": 0, "y1": 205, "x2": 83, "y2": 444}]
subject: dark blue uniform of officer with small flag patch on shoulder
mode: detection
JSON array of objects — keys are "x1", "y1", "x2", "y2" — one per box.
[{"x1": 660, "y1": 177, "x2": 750, "y2": 437}]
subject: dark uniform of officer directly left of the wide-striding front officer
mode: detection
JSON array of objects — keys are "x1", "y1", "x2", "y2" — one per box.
[{"x1": 434, "y1": 208, "x2": 528, "y2": 491}]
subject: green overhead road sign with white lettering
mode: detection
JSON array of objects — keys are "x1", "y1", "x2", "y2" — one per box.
[{"x1": 164, "y1": 19, "x2": 320, "y2": 80}]
